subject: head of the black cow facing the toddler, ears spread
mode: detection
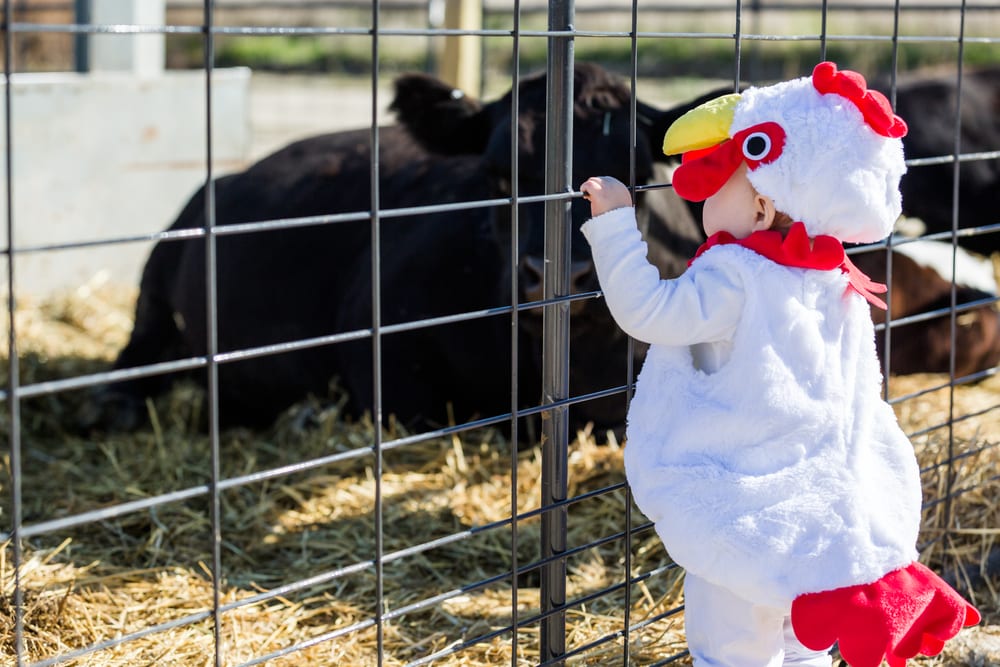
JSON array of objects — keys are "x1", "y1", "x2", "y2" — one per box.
[{"x1": 391, "y1": 63, "x2": 718, "y2": 308}]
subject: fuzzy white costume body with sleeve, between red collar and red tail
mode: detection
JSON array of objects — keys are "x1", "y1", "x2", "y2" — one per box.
[{"x1": 584, "y1": 209, "x2": 921, "y2": 607}]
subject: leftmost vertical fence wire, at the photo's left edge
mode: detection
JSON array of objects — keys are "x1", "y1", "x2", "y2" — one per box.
[{"x1": 3, "y1": 2, "x2": 25, "y2": 667}]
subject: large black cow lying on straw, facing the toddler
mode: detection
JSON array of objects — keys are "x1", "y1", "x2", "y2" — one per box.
[{"x1": 83, "y1": 64, "x2": 718, "y2": 438}]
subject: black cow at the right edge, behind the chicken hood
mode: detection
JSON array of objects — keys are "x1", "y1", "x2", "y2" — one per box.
[{"x1": 883, "y1": 68, "x2": 1000, "y2": 255}]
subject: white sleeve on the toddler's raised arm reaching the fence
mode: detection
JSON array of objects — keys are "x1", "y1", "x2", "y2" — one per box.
[{"x1": 582, "y1": 208, "x2": 744, "y2": 345}]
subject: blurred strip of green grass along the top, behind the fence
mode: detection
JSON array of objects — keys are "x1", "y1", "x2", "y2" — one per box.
[{"x1": 168, "y1": 27, "x2": 1000, "y2": 81}]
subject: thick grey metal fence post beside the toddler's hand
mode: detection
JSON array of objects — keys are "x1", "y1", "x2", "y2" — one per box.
[{"x1": 539, "y1": 0, "x2": 574, "y2": 662}]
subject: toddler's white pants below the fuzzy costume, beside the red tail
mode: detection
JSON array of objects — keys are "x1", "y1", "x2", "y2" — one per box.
[{"x1": 684, "y1": 573, "x2": 831, "y2": 667}]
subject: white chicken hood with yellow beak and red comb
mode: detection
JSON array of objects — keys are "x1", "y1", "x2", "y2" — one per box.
[{"x1": 664, "y1": 63, "x2": 906, "y2": 242}]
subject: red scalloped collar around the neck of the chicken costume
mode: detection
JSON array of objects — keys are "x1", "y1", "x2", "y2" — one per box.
[{"x1": 688, "y1": 222, "x2": 887, "y2": 310}]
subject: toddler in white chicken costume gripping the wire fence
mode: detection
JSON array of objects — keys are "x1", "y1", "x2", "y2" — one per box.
[{"x1": 582, "y1": 62, "x2": 979, "y2": 667}]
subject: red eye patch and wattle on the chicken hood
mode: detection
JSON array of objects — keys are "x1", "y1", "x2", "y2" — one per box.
[{"x1": 671, "y1": 122, "x2": 785, "y2": 201}]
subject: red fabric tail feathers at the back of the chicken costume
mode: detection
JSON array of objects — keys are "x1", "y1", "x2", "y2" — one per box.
[{"x1": 792, "y1": 562, "x2": 980, "y2": 667}]
